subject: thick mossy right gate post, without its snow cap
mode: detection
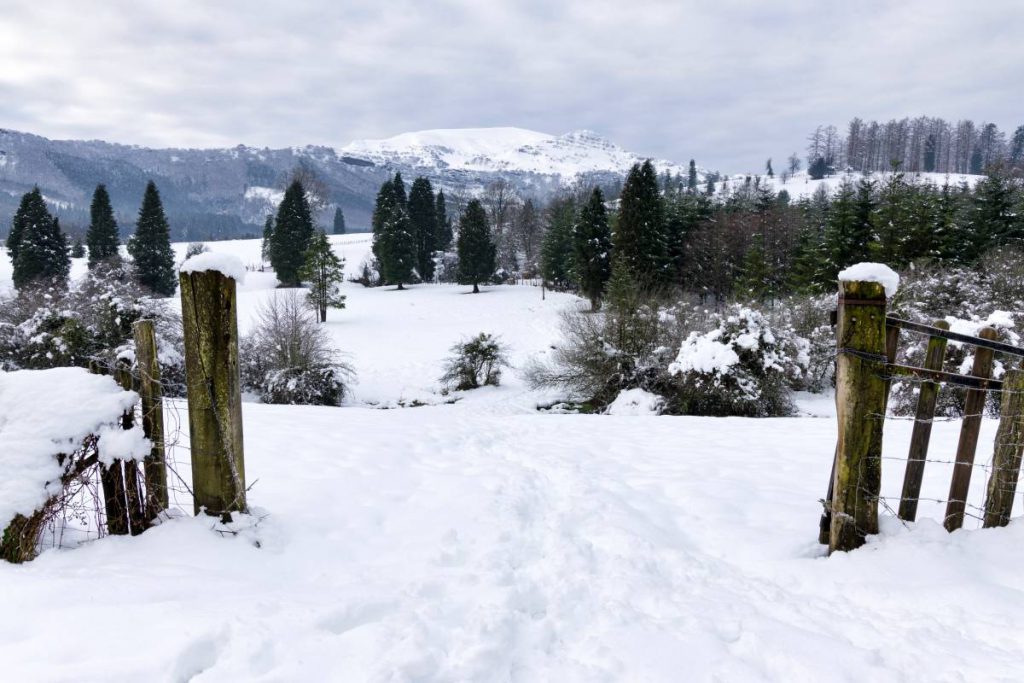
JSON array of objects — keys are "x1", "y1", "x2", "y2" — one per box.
[{"x1": 828, "y1": 281, "x2": 888, "y2": 552}]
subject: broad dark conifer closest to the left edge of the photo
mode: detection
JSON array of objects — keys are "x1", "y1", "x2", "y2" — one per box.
[{"x1": 7, "y1": 187, "x2": 71, "y2": 290}]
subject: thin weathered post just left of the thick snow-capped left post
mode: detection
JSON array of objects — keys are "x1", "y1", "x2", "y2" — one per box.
[{"x1": 132, "y1": 321, "x2": 169, "y2": 523}]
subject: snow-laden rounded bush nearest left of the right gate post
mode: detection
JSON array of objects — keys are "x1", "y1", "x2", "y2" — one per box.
[{"x1": 669, "y1": 307, "x2": 809, "y2": 417}]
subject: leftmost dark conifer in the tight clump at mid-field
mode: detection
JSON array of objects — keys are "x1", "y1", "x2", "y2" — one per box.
[{"x1": 373, "y1": 179, "x2": 417, "y2": 290}]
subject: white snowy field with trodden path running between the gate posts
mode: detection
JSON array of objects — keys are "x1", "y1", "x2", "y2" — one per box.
[{"x1": 0, "y1": 234, "x2": 1024, "y2": 682}]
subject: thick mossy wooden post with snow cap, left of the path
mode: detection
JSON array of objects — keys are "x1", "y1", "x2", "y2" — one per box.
[{"x1": 179, "y1": 252, "x2": 246, "y2": 521}]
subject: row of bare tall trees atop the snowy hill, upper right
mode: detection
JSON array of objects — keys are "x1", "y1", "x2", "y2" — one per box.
[{"x1": 807, "y1": 116, "x2": 1024, "y2": 178}]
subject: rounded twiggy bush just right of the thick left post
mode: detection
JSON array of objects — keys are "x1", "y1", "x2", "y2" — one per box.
[{"x1": 239, "y1": 292, "x2": 352, "y2": 405}]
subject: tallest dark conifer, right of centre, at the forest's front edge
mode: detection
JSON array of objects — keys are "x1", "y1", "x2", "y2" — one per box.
[{"x1": 614, "y1": 161, "x2": 672, "y2": 285}]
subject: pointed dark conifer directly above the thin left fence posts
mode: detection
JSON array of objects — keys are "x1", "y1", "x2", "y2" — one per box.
[{"x1": 128, "y1": 180, "x2": 178, "y2": 296}]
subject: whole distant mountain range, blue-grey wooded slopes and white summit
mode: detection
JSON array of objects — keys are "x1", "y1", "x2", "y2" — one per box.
[{"x1": 0, "y1": 128, "x2": 682, "y2": 240}]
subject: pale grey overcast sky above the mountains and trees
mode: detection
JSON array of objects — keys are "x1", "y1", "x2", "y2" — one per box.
[{"x1": 0, "y1": 0, "x2": 1024, "y2": 172}]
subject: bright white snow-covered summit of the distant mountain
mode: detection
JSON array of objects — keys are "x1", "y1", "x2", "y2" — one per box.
[{"x1": 342, "y1": 128, "x2": 681, "y2": 179}]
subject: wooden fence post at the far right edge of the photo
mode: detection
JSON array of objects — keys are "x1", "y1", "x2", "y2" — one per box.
[{"x1": 984, "y1": 370, "x2": 1024, "y2": 528}]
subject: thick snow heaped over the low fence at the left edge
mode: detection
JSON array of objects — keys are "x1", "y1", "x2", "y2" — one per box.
[{"x1": 0, "y1": 368, "x2": 150, "y2": 528}]
